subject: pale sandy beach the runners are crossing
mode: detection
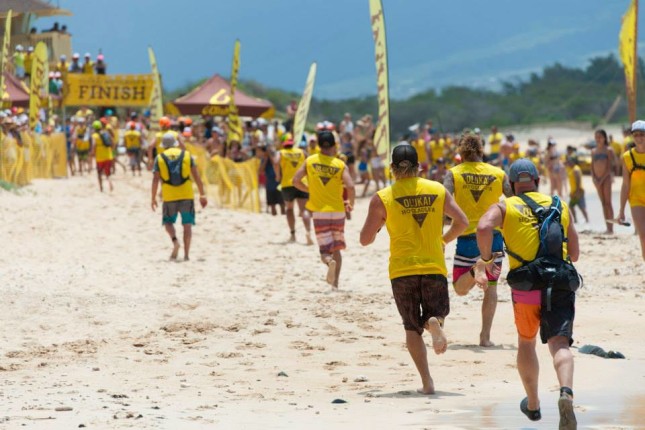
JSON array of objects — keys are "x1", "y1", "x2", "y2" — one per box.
[{"x1": 0, "y1": 131, "x2": 645, "y2": 429}]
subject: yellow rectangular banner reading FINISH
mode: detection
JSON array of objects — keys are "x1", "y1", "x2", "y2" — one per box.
[{"x1": 63, "y1": 73, "x2": 154, "y2": 107}]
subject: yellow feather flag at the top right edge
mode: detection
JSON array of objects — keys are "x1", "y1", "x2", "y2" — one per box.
[{"x1": 618, "y1": 0, "x2": 638, "y2": 122}]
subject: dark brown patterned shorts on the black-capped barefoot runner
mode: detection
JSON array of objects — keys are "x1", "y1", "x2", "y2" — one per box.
[{"x1": 391, "y1": 275, "x2": 450, "y2": 334}]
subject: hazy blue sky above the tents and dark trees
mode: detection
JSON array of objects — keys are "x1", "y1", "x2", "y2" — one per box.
[{"x1": 37, "y1": 0, "x2": 645, "y2": 98}]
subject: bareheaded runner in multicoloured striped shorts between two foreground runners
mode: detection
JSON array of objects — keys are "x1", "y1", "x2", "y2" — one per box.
[{"x1": 443, "y1": 133, "x2": 513, "y2": 347}]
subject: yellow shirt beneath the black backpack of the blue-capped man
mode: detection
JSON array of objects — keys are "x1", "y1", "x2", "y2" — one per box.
[{"x1": 502, "y1": 192, "x2": 569, "y2": 269}]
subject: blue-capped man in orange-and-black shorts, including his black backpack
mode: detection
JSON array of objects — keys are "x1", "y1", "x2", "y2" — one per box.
[{"x1": 475, "y1": 158, "x2": 580, "y2": 430}]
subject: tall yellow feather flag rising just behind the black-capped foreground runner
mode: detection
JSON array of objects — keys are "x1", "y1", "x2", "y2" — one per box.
[{"x1": 370, "y1": 0, "x2": 390, "y2": 164}]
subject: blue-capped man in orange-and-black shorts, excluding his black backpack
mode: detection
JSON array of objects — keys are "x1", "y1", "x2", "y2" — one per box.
[{"x1": 476, "y1": 158, "x2": 580, "y2": 430}]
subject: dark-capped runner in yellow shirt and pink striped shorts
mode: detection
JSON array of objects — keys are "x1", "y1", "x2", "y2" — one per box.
[{"x1": 293, "y1": 130, "x2": 355, "y2": 290}]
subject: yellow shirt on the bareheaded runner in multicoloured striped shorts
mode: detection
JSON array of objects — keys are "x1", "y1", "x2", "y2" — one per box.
[{"x1": 450, "y1": 161, "x2": 504, "y2": 236}]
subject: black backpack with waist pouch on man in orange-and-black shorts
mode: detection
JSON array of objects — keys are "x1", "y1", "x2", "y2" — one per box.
[{"x1": 506, "y1": 194, "x2": 582, "y2": 292}]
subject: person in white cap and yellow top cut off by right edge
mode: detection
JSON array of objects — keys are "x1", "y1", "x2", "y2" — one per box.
[{"x1": 618, "y1": 120, "x2": 645, "y2": 261}]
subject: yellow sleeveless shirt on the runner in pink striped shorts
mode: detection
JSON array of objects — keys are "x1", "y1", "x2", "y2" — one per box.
[{"x1": 305, "y1": 153, "x2": 345, "y2": 212}]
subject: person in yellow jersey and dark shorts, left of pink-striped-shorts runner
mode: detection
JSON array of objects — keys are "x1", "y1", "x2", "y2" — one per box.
[{"x1": 273, "y1": 139, "x2": 314, "y2": 245}]
